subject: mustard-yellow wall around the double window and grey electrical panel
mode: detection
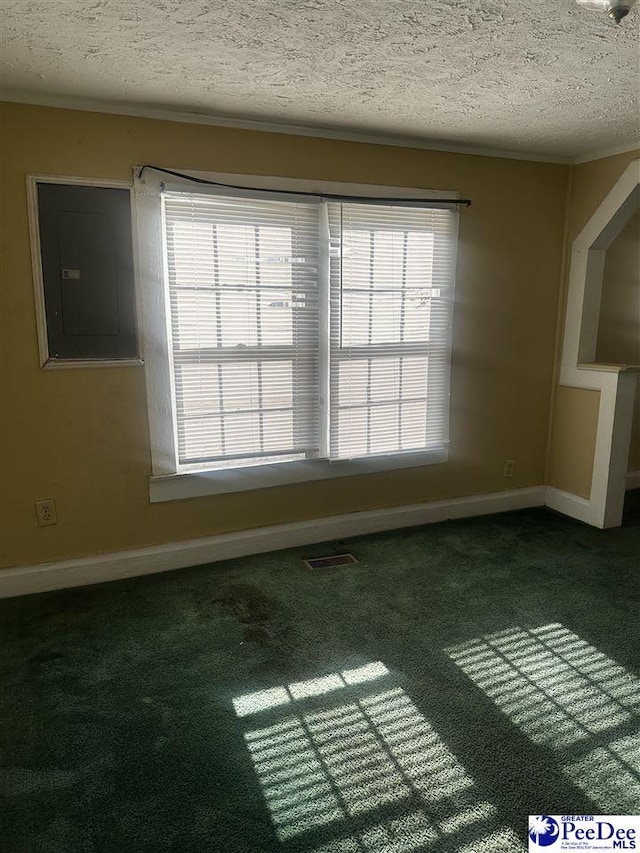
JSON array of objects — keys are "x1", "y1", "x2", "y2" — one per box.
[{"x1": 1, "y1": 104, "x2": 569, "y2": 565}]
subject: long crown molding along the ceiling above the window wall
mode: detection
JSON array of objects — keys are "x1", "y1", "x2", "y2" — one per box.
[{"x1": 0, "y1": 90, "x2": 572, "y2": 165}]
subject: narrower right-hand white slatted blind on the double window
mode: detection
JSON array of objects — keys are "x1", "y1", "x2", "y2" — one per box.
[{"x1": 328, "y1": 203, "x2": 458, "y2": 459}]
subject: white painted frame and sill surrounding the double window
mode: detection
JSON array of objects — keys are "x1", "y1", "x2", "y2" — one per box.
[{"x1": 133, "y1": 167, "x2": 460, "y2": 503}]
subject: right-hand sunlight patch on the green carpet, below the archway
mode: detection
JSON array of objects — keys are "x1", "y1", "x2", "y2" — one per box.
[{"x1": 446, "y1": 623, "x2": 640, "y2": 814}]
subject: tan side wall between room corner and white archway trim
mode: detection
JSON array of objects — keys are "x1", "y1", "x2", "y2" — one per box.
[{"x1": 547, "y1": 150, "x2": 640, "y2": 497}]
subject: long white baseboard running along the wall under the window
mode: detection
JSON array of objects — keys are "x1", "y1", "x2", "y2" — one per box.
[{"x1": 0, "y1": 486, "x2": 545, "y2": 598}]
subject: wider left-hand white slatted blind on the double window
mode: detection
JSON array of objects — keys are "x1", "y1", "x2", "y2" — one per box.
[{"x1": 164, "y1": 193, "x2": 319, "y2": 468}]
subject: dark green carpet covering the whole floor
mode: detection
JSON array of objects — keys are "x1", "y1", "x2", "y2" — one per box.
[{"x1": 0, "y1": 492, "x2": 640, "y2": 853}]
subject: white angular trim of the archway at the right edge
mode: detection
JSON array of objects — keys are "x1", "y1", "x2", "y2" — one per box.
[{"x1": 547, "y1": 159, "x2": 640, "y2": 528}]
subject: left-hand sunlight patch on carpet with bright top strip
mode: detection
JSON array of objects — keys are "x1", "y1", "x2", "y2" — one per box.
[{"x1": 233, "y1": 661, "x2": 524, "y2": 853}]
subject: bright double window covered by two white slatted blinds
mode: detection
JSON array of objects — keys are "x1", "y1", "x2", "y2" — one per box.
[{"x1": 141, "y1": 176, "x2": 457, "y2": 499}]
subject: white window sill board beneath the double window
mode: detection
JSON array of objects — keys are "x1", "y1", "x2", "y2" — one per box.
[{"x1": 149, "y1": 447, "x2": 449, "y2": 503}]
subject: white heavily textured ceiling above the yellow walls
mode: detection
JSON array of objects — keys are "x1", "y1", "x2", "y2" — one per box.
[{"x1": 0, "y1": 0, "x2": 640, "y2": 157}]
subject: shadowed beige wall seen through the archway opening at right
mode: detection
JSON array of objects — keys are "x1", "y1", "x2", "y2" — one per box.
[{"x1": 596, "y1": 211, "x2": 640, "y2": 471}]
